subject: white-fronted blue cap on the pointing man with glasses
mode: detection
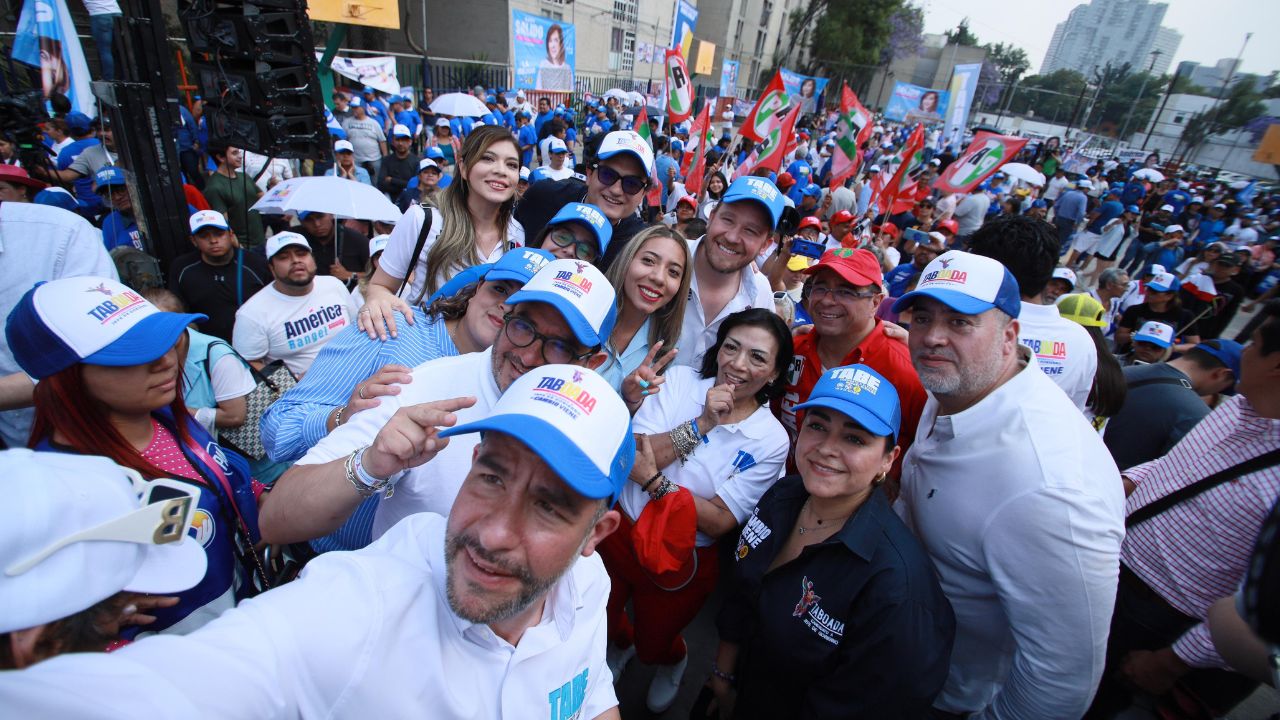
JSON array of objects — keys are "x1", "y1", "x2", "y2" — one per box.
[{"x1": 507, "y1": 259, "x2": 618, "y2": 347}]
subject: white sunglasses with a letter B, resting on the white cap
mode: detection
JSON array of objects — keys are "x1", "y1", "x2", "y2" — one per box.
[{"x1": 4, "y1": 468, "x2": 200, "y2": 578}]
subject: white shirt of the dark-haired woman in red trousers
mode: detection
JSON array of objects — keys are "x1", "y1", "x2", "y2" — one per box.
[{"x1": 618, "y1": 368, "x2": 790, "y2": 547}]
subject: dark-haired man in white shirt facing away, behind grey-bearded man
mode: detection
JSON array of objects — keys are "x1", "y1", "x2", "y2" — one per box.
[{"x1": 969, "y1": 215, "x2": 1098, "y2": 411}]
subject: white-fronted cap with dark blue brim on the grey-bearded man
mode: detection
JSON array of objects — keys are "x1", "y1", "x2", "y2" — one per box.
[{"x1": 893, "y1": 250, "x2": 1023, "y2": 318}]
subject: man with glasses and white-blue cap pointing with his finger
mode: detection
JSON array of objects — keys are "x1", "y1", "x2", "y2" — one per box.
[{"x1": 259, "y1": 260, "x2": 617, "y2": 543}]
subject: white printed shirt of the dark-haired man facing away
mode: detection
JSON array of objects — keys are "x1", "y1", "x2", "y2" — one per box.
[{"x1": 1018, "y1": 297, "x2": 1098, "y2": 410}]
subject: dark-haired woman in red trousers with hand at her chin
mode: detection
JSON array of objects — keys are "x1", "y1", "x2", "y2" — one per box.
[{"x1": 599, "y1": 307, "x2": 792, "y2": 712}]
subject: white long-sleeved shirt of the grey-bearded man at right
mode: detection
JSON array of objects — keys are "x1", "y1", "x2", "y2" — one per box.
[{"x1": 895, "y1": 356, "x2": 1124, "y2": 720}]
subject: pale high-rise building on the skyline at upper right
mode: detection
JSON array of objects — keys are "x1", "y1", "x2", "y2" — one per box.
[{"x1": 1039, "y1": 0, "x2": 1183, "y2": 76}]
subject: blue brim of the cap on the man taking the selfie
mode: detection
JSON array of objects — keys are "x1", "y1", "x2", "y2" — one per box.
[{"x1": 440, "y1": 414, "x2": 635, "y2": 502}]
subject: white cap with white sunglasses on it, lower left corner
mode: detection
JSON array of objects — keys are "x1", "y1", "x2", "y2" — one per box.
[{"x1": 0, "y1": 450, "x2": 207, "y2": 633}]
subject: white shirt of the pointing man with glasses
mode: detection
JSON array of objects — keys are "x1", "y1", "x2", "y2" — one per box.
[{"x1": 297, "y1": 348, "x2": 500, "y2": 539}]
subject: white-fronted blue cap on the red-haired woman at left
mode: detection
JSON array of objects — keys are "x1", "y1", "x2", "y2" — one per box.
[{"x1": 5, "y1": 275, "x2": 209, "y2": 379}]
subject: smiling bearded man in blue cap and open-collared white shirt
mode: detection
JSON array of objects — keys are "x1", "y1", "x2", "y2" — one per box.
[{"x1": 676, "y1": 177, "x2": 786, "y2": 368}]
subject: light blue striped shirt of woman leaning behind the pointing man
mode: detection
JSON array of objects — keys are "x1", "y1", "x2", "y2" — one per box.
[{"x1": 262, "y1": 307, "x2": 458, "y2": 552}]
